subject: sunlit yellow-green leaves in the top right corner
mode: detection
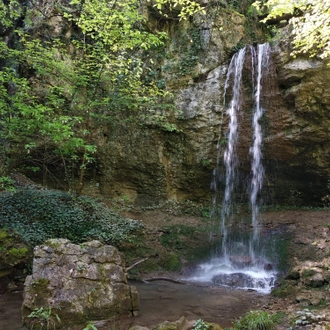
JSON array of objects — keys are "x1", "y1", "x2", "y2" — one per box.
[{"x1": 255, "y1": 0, "x2": 330, "y2": 59}]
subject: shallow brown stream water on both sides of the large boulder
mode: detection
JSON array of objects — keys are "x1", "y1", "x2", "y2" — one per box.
[{"x1": 0, "y1": 280, "x2": 270, "y2": 330}]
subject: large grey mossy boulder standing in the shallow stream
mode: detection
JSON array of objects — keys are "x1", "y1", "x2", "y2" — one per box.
[{"x1": 22, "y1": 239, "x2": 139, "y2": 328}]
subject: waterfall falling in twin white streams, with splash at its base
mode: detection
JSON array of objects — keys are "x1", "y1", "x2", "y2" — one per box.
[{"x1": 186, "y1": 44, "x2": 276, "y2": 292}]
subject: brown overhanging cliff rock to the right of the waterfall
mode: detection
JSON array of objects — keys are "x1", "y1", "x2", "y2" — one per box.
[{"x1": 269, "y1": 35, "x2": 330, "y2": 204}]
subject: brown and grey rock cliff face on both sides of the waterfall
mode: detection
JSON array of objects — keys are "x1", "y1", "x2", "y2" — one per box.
[{"x1": 6, "y1": 1, "x2": 330, "y2": 205}]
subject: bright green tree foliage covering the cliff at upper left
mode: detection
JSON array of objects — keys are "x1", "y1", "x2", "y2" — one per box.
[{"x1": 0, "y1": 0, "x2": 176, "y2": 193}]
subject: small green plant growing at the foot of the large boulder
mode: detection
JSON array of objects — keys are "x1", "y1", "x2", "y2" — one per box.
[{"x1": 28, "y1": 307, "x2": 61, "y2": 330}]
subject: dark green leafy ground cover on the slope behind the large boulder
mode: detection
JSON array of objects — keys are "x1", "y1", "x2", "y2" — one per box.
[{"x1": 0, "y1": 189, "x2": 142, "y2": 246}]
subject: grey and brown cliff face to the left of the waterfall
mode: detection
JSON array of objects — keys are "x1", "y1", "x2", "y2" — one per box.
[{"x1": 94, "y1": 7, "x2": 245, "y2": 204}]
